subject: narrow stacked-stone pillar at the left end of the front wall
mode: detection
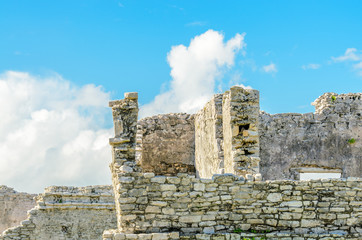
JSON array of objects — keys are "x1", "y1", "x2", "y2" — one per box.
[{"x1": 109, "y1": 92, "x2": 140, "y2": 230}]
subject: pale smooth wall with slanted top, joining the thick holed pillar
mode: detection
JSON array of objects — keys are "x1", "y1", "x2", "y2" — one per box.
[{"x1": 195, "y1": 94, "x2": 224, "y2": 178}]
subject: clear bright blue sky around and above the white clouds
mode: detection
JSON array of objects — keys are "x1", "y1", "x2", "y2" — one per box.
[{"x1": 0, "y1": 0, "x2": 362, "y2": 113}]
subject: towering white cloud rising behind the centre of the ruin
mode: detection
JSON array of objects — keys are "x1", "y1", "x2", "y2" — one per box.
[{"x1": 140, "y1": 30, "x2": 245, "y2": 117}]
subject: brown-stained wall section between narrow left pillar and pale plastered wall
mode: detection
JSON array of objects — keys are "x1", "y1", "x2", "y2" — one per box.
[{"x1": 137, "y1": 113, "x2": 195, "y2": 175}]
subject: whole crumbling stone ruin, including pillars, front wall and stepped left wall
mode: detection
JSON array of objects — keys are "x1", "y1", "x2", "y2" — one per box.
[{"x1": 0, "y1": 87, "x2": 362, "y2": 240}]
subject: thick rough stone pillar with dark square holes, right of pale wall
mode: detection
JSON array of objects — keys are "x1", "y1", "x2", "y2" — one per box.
[{"x1": 223, "y1": 86, "x2": 261, "y2": 180}]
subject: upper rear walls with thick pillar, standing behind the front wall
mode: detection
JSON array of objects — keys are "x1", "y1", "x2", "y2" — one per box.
[{"x1": 126, "y1": 87, "x2": 362, "y2": 180}]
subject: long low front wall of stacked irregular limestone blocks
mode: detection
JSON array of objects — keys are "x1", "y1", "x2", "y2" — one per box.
[{"x1": 111, "y1": 173, "x2": 362, "y2": 235}]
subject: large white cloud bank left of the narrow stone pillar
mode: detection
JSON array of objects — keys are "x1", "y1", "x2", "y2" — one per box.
[{"x1": 0, "y1": 71, "x2": 111, "y2": 192}]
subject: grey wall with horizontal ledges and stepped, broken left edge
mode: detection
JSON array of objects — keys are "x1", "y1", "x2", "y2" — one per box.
[{"x1": 0, "y1": 186, "x2": 117, "y2": 240}]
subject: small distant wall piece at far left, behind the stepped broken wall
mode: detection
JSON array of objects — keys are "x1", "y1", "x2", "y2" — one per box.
[{"x1": 0, "y1": 185, "x2": 36, "y2": 233}]
